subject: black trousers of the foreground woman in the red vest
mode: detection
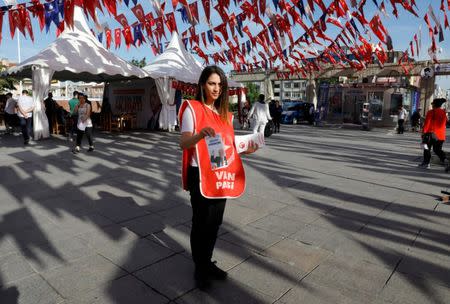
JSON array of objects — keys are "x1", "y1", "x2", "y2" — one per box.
[{"x1": 188, "y1": 167, "x2": 227, "y2": 268}]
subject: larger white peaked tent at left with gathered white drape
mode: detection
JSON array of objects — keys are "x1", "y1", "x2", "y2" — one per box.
[{"x1": 7, "y1": 6, "x2": 150, "y2": 139}]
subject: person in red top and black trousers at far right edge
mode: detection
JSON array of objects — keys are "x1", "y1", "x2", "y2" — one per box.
[{"x1": 419, "y1": 98, "x2": 448, "y2": 170}]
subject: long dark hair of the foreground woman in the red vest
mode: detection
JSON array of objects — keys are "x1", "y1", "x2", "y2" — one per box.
[{"x1": 195, "y1": 65, "x2": 228, "y2": 122}]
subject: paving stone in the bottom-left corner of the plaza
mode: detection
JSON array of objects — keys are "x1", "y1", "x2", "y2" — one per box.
[{"x1": 0, "y1": 274, "x2": 63, "y2": 304}]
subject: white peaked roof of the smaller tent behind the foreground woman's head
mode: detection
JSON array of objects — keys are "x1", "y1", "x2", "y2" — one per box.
[{"x1": 144, "y1": 32, "x2": 203, "y2": 84}]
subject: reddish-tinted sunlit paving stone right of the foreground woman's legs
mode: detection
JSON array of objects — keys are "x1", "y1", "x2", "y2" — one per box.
[{"x1": 249, "y1": 215, "x2": 306, "y2": 237}]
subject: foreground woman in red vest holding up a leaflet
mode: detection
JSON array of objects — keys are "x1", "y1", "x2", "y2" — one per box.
[{"x1": 179, "y1": 66, "x2": 257, "y2": 290}]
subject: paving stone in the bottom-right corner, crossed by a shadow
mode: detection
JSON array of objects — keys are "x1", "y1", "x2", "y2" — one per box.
[{"x1": 380, "y1": 272, "x2": 450, "y2": 304}]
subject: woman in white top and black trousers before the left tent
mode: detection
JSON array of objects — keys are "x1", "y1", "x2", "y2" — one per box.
[{"x1": 73, "y1": 93, "x2": 94, "y2": 154}]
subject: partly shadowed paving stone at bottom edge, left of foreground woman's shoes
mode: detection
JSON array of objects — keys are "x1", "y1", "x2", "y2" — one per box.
[{"x1": 67, "y1": 275, "x2": 169, "y2": 304}]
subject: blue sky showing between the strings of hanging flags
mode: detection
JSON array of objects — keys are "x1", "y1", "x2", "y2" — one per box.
[{"x1": 0, "y1": 0, "x2": 450, "y2": 89}]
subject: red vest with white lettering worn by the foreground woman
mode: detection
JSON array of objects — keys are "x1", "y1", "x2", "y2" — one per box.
[{"x1": 179, "y1": 100, "x2": 245, "y2": 198}]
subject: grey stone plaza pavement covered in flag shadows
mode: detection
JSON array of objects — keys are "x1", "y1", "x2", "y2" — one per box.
[{"x1": 0, "y1": 125, "x2": 450, "y2": 304}]
